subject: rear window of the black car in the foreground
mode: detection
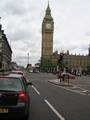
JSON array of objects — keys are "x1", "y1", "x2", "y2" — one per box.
[{"x1": 0, "y1": 78, "x2": 22, "y2": 91}]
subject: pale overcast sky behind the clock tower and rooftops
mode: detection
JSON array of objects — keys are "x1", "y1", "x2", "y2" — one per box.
[{"x1": 0, "y1": 0, "x2": 90, "y2": 66}]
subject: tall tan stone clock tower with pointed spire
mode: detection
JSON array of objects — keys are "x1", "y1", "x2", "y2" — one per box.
[{"x1": 41, "y1": 3, "x2": 54, "y2": 62}]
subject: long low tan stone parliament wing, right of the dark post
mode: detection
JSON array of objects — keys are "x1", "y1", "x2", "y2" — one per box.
[{"x1": 63, "y1": 48, "x2": 90, "y2": 70}]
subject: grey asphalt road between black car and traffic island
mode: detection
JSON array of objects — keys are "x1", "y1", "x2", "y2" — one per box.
[{"x1": 27, "y1": 73, "x2": 90, "y2": 120}]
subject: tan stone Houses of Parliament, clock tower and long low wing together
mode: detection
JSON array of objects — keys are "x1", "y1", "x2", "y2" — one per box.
[{"x1": 41, "y1": 3, "x2": 90, "y2": 72}]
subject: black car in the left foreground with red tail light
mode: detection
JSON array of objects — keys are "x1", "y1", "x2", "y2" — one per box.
[{"x1": 0, "y1": 74, "x2": 31, "y2": 120}]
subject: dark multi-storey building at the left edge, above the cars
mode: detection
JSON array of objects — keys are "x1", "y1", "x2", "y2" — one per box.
[{"x1": 0, "y1": 20, "x2": 12, "y2": 70}]
